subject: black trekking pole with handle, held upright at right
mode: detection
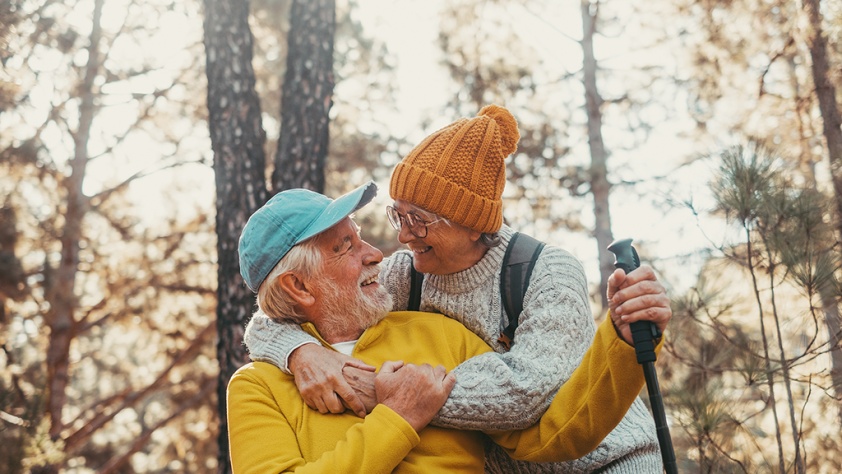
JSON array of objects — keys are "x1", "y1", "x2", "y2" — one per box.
[{"x1": 608, "y1": 239, "x2": 678, "y2": 474}]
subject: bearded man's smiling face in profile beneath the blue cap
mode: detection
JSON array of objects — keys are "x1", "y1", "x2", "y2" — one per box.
[{"x1": 313, "y1": 218, "x2": 392, "y2": 342}]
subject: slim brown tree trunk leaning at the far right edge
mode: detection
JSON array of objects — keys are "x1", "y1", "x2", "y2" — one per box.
[{"x1": 803, "y1": 0, "x2": 842, "y2": 424}]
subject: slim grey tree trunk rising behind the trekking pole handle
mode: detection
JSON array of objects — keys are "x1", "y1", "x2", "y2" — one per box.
[{"x1": 581, "y1": 0, "x2": 614, "y2": 313}]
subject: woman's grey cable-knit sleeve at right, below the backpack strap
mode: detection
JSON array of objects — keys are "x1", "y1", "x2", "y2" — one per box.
[{"x1": 433, "y1": 250, "x2": 596, "y2": 430}]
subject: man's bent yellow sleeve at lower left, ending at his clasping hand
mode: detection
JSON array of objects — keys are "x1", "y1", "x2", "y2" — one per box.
[{"x1": 228, "y1": 371, "x2": 420, "y2": 474}]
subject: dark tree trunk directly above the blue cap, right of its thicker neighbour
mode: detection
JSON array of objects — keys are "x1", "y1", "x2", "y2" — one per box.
[{"x1": 272, "y1": 0, "x2": 336, "y2": 193}]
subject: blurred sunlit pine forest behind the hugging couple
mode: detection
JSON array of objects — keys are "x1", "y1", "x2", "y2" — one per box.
[{"x1": 0, "y1": 0, "x2": 842, "y2": 473}]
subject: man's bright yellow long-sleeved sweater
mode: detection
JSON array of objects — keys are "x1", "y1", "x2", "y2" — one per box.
[{"x1": 228, "y1": 311, "x2": 644, "y2": 474}]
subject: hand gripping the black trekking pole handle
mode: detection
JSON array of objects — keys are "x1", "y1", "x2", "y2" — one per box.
[{"x1": 608, "y1": 265, "x2": 672, "y2": 344}]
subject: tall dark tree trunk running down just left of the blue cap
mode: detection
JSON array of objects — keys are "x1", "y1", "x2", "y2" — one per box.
[{"x1": 204, "y1": 0, "x2": 267, "y2": 472}]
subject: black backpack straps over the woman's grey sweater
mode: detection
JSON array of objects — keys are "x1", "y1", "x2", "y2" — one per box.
[{"x1": 407, "y1": 232, "x2": 544, "y2": 350}]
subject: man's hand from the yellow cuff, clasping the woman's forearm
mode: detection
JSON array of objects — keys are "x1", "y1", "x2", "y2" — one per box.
[{"x1": 374, "y1": 361, "x2": 456, "y2": 432}]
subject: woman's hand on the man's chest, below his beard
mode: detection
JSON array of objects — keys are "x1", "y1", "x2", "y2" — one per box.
[{"x1": 289, "y1": 344, "x2": 374, "y2": 417}]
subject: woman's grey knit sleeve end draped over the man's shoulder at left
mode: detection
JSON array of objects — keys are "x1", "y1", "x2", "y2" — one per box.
[{"x1": 243, "y1": 310, "x2": 319, "y2": 374}]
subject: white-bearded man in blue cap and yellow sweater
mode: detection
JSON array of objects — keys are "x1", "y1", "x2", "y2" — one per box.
[{"x1": 228, "y1": 183, "x2": 668, "y2": 472}]
